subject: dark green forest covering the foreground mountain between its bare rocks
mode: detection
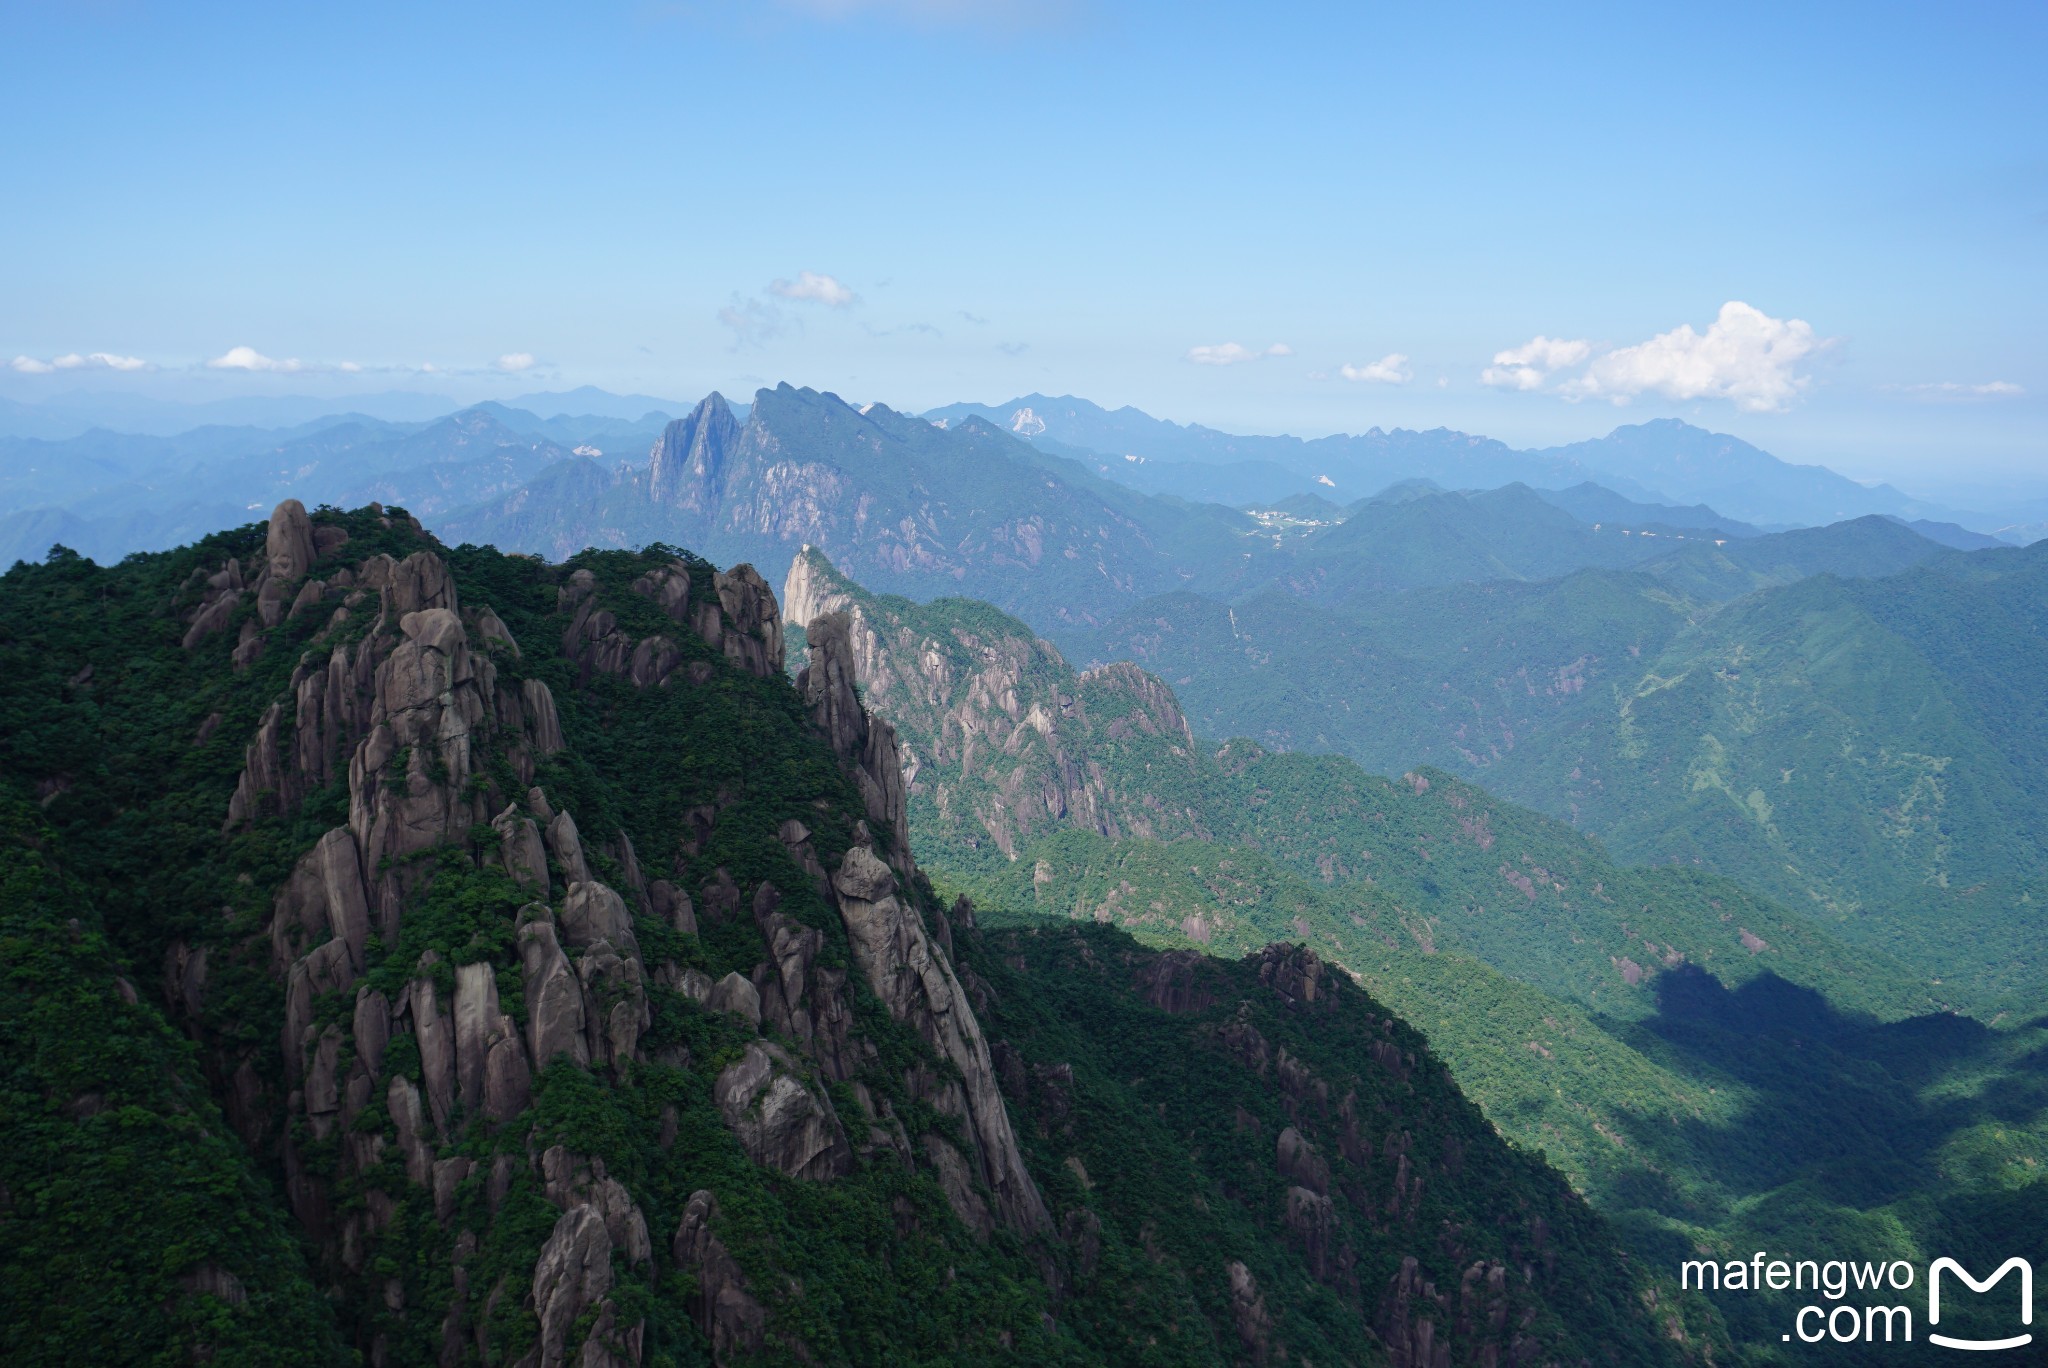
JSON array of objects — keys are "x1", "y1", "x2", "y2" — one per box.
[{"x1": 0, "y1": 508, "x2": 1687, "y2": 1364}]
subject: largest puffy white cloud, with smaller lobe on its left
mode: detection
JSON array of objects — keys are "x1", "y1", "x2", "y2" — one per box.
[{"x1": 1479, "y1": 299, "x2": 1827, "y2": 414}]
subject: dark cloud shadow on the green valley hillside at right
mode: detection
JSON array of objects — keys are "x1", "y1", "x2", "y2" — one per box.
[{"x1": 1628, "y1": 965, "x2": 2048, "y2": 1208}]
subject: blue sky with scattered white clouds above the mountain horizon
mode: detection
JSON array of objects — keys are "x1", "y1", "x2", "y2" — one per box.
[{"x1": 0, "y1": 0, "x2": 2048, "y2": 491}]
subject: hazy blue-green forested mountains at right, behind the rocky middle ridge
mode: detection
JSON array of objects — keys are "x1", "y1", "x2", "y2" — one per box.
[{"x1": 1079, "y1": 540, "x2": 2048, "y2": 1010}]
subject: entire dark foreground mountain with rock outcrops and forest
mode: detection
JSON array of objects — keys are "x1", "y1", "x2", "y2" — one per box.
[{"x1": 0, "y1": 504, "x2": 1718, "y2": 1366}]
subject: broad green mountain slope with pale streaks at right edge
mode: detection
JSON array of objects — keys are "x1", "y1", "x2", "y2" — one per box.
[{"x1": 1489, "y1": 551, "x2": 2048, "y2": 1008}]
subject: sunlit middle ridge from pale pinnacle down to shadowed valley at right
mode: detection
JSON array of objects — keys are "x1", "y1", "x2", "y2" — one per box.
[{"x1": 786, "y1": 551, "x2": 2048, "y2": 1362}]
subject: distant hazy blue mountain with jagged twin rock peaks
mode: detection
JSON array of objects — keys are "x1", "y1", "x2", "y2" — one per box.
[{"x1": 440, "y1": 385, "x2": 1264, "y2": 625}]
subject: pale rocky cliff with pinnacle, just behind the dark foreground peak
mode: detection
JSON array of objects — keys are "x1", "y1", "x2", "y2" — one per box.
[{"x1": 782, "y1": 547, "x2": 1208, "y2": 858}]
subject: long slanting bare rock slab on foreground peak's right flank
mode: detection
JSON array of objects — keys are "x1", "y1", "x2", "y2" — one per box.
[{"x1": 831, "y1": 846, "x2": 1053, "y2": 1233}]
